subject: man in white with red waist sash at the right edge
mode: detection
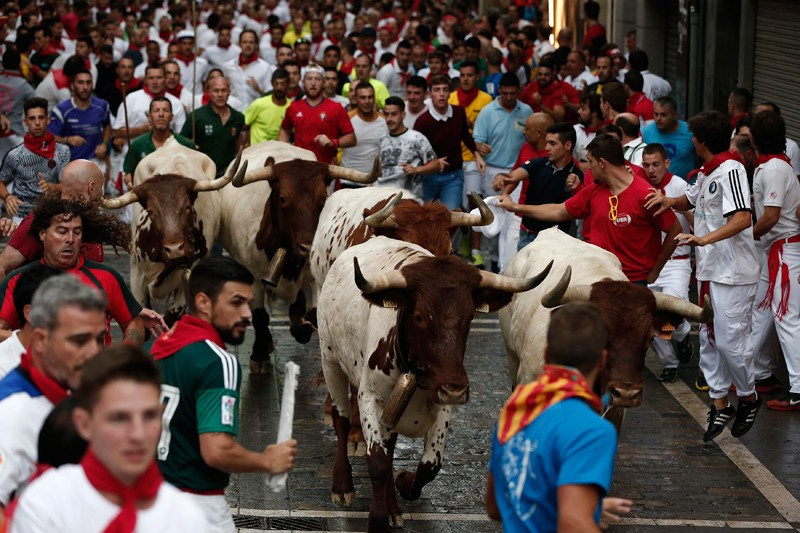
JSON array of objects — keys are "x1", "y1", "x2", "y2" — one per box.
[{"x1": 750, "y1": 111, "x2": 800, "y2": 411}]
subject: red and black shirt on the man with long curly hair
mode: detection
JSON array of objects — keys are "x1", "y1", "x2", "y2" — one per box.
[{"x1": 0, "y1": 257, "x2": 142, "y2": 346}]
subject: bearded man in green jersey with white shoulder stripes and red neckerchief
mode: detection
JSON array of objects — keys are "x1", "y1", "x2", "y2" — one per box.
[{"x1": 150, "y1": 256, "x2": 297, "y2": 532}]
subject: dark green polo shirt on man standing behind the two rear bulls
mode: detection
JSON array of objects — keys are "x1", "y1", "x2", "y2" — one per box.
[{"x1": 181, "y1": 104, "x2": 244, "y2": 175}]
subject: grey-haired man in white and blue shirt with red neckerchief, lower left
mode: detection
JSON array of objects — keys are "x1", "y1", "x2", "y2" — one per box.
[{"x1": 0, "y1": 275, "x2": 107, "y2": 510}]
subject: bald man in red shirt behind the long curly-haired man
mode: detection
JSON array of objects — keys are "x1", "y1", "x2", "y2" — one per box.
[{"x1": 0, "y1": 159, "x2": 105, "y2": 279}]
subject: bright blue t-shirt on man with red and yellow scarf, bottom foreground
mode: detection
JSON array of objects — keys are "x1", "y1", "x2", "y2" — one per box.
[{"x1": 489, "y1": 398, "x2": 617, "y2": 533}]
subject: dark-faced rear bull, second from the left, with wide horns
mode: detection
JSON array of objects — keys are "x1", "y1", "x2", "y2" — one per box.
[{"x1": 220, "y1": 141, "x2": 379, "y2": 372}]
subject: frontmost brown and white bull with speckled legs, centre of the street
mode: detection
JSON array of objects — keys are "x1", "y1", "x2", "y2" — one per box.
[{"x1": 318, "y1": 237, "x2": 549, "y2": 532}]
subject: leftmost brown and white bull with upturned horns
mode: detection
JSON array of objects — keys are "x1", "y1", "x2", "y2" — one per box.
[{"x1": 102, "y1": 138, "x2": 246, "y2": 324}]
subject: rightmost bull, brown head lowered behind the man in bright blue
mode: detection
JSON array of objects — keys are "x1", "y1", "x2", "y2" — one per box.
[{"x1": 500, "y1": 228, "x2": 713, "y2": 407}]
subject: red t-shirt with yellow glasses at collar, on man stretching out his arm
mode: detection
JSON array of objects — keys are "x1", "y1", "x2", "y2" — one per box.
[{"x1": 564, "y1": 176, "x2": 677, "y2": 281}]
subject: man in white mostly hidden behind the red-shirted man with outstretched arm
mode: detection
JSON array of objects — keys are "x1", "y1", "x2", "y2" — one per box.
[{"x1": 642, "y1": 143, "x2": 694, "y2": 382}]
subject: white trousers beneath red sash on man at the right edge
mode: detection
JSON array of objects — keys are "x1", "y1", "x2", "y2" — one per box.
[{"x1": 752, "y1": 243, "x2": 800, "y2": 393}]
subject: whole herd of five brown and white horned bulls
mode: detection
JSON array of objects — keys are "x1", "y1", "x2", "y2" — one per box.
[{"x1": 98, "y1": 140, "x2": 712, "y2": 531}]
